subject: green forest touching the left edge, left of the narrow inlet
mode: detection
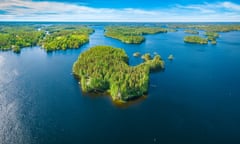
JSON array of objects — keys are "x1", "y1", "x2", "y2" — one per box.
[{"x1": 0, "y1": 25, "x2": 44, "y2": 53}]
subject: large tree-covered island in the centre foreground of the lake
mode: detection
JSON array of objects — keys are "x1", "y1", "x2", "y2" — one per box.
[{"x1": 73, "y1": 46, "x2": 164, "y2": 101}]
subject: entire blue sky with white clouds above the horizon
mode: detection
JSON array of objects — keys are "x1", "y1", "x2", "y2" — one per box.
[{"x1": 0, "y1": 0, "x2": 240, "y2": 22}]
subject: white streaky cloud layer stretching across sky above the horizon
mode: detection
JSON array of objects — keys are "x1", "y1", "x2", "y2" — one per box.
[{"x1": 0, "y1": 0, "x2": 240, "y2": 22}]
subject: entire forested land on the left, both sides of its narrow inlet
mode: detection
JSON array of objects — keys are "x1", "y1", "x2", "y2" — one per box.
[{"x1": 0, "y1": 25, "x2": 94, "y2": 53}]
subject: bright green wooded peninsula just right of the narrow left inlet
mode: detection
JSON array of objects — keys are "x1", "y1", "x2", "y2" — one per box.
[{"x1": 41, "y1": 26, "x2": 93, "y2": 51}]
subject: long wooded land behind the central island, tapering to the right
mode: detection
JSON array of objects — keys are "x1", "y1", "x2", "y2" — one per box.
[{"x1": 105, "y1": 26, "x2": 167, "y2": 44}]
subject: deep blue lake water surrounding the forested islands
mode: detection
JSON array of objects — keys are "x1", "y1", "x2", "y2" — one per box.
[{"x1": 0, "y1": 25, "x2": 240, "y2": 144}]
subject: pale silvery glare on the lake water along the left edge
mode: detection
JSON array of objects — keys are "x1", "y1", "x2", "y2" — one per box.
[{"x1": 0, "y1": 56, "x2": 30, "y2": 144}]
